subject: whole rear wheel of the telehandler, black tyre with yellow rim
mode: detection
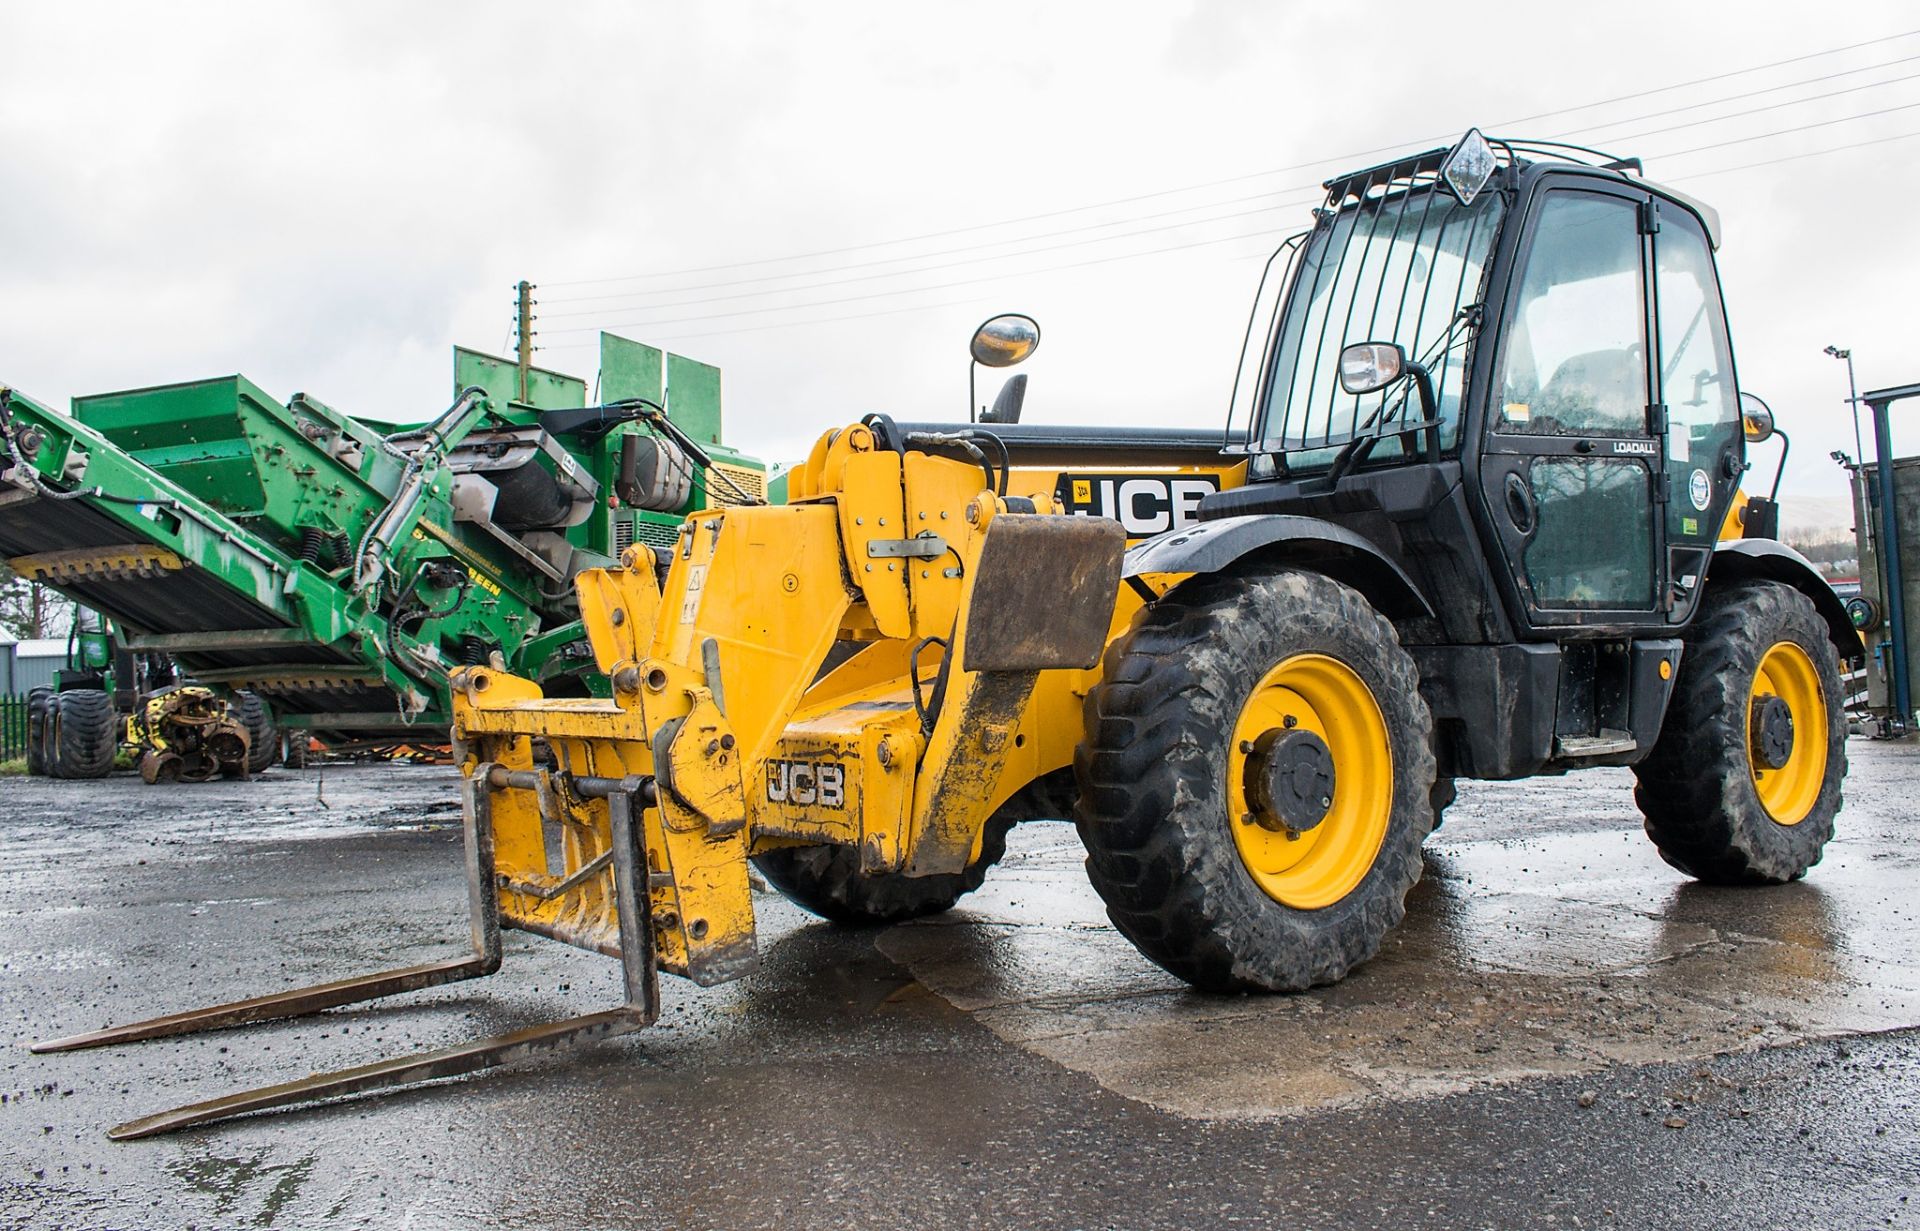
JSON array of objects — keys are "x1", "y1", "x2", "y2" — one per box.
[{"x1": 1634, "y1": 582, "x2": 1847, "y2": 885}]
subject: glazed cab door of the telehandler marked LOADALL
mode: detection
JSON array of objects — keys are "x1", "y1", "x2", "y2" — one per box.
[{"x1": 1480, "y1": 181, "x2": 1667, "y2": 630}]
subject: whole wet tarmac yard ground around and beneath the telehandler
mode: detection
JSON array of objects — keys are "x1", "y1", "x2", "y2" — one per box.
[{"x1": 0, "y1": 739, "x2": 1920, "y2": 1231}]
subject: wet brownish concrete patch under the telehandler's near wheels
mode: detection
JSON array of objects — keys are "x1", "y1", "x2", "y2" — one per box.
[{"x1": 877, "y1": 803, "x2": 1920, "y2": 1118}]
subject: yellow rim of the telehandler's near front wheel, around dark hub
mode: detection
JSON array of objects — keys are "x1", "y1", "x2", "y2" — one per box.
[{"x1": 1227, "y1": 655, "x2": 1394, "y2": 910}]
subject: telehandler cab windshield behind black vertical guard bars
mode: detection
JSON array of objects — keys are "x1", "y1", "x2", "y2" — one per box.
[{"x1": 1260, "y1": 188, "x2": 1503, "y2": 469}]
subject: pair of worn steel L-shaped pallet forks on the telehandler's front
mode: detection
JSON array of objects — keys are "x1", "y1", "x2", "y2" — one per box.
[{"x1": 33, "y1": 764, "x2": 660, "y2": 1141}]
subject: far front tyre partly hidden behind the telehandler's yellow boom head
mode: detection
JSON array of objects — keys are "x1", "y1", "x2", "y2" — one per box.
[{"x1": 753, "y1": 772, "x2": 1073, "y2": 928}]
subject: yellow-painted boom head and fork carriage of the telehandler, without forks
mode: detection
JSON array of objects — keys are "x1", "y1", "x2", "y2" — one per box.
[{"x1": 453, "y1": 424, "x2": 1244, "y2": 983}]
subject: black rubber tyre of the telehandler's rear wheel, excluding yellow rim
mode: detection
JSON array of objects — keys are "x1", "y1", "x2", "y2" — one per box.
[{"x1": 1634, "y1": 582, "x2": 1847, "y2": 885}]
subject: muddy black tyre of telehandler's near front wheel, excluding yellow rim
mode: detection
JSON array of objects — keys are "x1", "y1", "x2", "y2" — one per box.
[{"x1": 1073, "y1": 570, "x2": 1434, "y2": 991}]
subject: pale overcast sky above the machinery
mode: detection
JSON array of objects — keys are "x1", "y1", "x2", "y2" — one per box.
[{"x1": 0, "y1": 0, "x2": 1920, "y2": 522}]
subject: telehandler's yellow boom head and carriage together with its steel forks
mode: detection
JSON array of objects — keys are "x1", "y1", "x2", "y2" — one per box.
[{"x1": 35, "y1": 426, "x2": 1123, "y2": 1139}]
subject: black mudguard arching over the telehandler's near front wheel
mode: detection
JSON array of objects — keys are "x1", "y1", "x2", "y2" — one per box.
[{"x1": 1119, "y1": 513, "x2": 1434, "y2": 618}]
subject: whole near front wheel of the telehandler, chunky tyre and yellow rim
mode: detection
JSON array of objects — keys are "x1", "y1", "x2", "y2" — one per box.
[{"x1": 1075, "y1": 570, "x2": 1434, "y2": 991}]
